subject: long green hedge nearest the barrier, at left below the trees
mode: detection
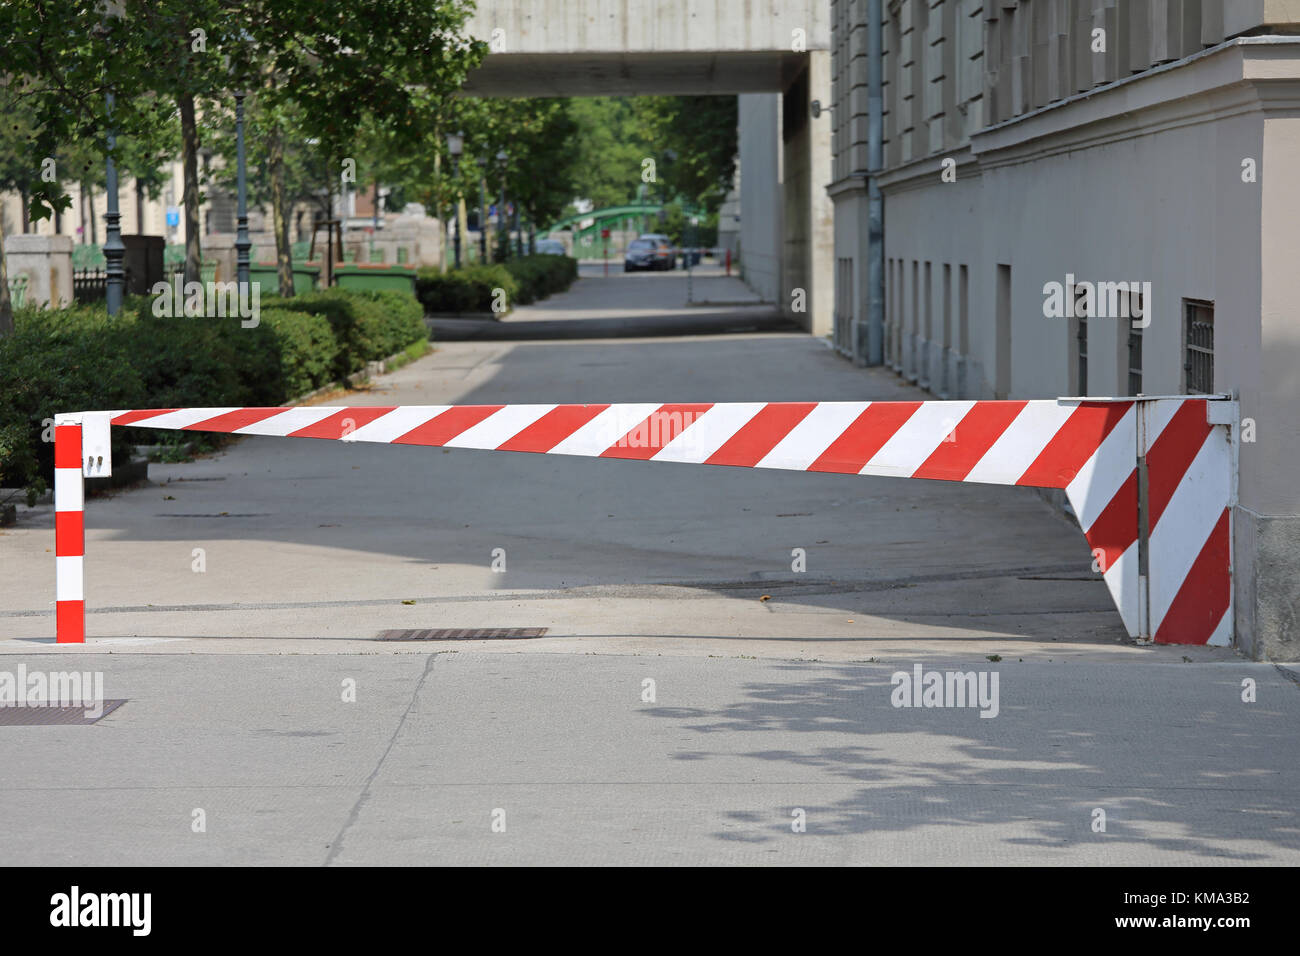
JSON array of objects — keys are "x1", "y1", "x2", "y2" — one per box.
[{"x1": 0, "y1": 289, "x2": 428, "y2": 497}]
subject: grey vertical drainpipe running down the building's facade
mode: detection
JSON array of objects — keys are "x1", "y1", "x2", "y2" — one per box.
[{"x1": 854, "y1": 0, "x2": 885, "y2": 365}]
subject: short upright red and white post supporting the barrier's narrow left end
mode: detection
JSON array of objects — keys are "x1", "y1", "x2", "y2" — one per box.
[{"x1": 55, "y1": 419, "x2": 86, "y2": 644}]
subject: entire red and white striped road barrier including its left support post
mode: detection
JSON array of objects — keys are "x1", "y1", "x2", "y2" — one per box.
[{"x1": 55, "y1": 397, "x2": 1236, "y2": 645}]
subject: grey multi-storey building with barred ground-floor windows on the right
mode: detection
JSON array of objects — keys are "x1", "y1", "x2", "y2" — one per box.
[{"x1": 820, "y1": 0, "x2": 1300, "y2": 659}]
